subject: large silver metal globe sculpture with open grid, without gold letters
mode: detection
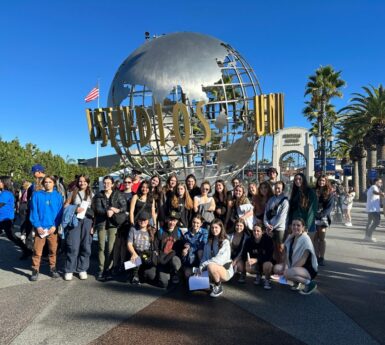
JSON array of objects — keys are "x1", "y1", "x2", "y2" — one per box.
[{"x1": 108, "y1": 32, "x2": 261, "y2": 182}]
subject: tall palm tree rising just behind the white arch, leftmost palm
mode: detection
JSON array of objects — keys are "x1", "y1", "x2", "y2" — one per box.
[{"x1": 303, "y1": 65, "x2": 346, "y2": 168}]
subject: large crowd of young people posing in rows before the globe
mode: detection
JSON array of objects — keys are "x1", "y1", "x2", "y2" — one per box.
[{"x1": 0, "y1": 164, "x2": 334, "y2": 297}]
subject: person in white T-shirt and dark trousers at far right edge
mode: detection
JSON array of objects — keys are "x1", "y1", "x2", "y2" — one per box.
[{"x1": 364, "y1": 178, "x2": 385, "y2": 242}]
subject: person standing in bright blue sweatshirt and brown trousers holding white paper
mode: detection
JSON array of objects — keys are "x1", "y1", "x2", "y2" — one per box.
[{"x1": 30, "y1": 176, "x2": 63, "y2": 281}]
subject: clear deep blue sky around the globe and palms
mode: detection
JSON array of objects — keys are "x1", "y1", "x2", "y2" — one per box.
[{"x1": 0, "y1": 0, "x2": 385, "y2": 163}]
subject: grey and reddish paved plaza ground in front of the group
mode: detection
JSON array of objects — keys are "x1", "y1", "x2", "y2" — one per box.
[{"x1": 0, "y1": 204, "x2": 385, "y2": 345}]
